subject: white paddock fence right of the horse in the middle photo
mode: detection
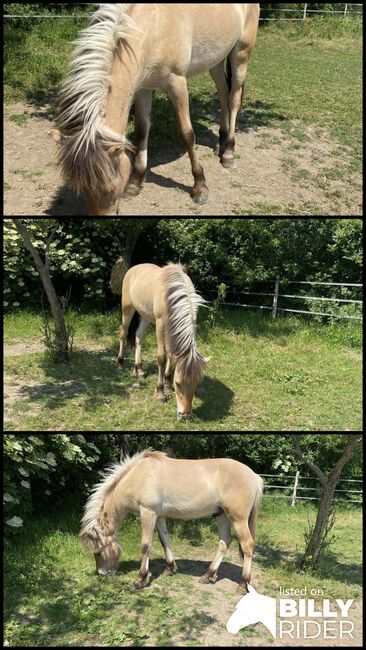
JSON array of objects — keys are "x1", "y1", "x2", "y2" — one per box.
[{"x1": 208, "y1": 276, "x2": 363, "y2": 321}]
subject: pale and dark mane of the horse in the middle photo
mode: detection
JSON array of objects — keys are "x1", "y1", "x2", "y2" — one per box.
[{"x1": 162, "y1": 264, "x2": 206, "y2": 383}]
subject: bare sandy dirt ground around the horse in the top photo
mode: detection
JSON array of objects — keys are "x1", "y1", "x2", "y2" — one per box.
[{"x1": 4, "y1": 104, "x2": 362, "y2": 216}]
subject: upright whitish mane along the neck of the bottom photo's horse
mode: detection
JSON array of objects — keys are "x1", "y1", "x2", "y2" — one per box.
[{"x1": 80, "y1": 449, "x2": 160, "y2": 536}]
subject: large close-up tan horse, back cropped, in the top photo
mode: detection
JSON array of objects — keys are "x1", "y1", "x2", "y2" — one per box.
[{"x1": 49, "y1": 3, "x2": 260, "y2": 216}]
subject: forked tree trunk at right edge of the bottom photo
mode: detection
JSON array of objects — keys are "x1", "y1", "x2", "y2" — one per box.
[{"x1": 290, "y1": 434, "x2": 362, "y2": 569}]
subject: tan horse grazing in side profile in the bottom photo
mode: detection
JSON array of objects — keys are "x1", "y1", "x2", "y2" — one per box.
[{"x1": 80, "y1": 449, "x2": 263, "y2": 594}]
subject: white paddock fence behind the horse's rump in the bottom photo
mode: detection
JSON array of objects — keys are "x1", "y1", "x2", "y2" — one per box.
[{"x1": 260, "y1": 472, "x2": 363, "y2": 507}]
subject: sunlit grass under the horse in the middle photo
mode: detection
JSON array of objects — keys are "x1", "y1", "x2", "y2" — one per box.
[{"x1": 4, "y1": 310, "x2": 362, "y2": 431}]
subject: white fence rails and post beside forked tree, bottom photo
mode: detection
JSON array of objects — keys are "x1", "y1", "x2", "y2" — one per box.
[{"x1": 260, "y1": 472, "x2": 363, "y2": 507}]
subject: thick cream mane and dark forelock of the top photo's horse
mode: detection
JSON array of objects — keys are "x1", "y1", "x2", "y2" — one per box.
[{"x1": 56, "y1": 4, "x2": 138, "y2": 192}]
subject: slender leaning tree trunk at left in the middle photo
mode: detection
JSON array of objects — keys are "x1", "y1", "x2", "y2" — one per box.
[{"x1": 13, "y1": 219, "x2": 69, "y2": 362}]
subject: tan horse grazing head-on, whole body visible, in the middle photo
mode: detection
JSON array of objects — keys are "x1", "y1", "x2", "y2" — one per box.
[{"x1": 117, "y1": 264, "x2": 210, "y2": 420}]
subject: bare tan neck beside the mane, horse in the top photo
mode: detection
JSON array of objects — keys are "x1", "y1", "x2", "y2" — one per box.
[{"x1": 105, "y1": 50, "x2": 140, "y2": 135}]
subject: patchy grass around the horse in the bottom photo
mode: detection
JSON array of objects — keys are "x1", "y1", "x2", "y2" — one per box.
[{"x1": 4, "y1": 498, "x2": 362, "y2": 647}]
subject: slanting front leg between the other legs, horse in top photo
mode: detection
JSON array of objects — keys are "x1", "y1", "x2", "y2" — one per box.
[{"x1": 165, "y1": 74, "x2": 208, "y2": 205}]
